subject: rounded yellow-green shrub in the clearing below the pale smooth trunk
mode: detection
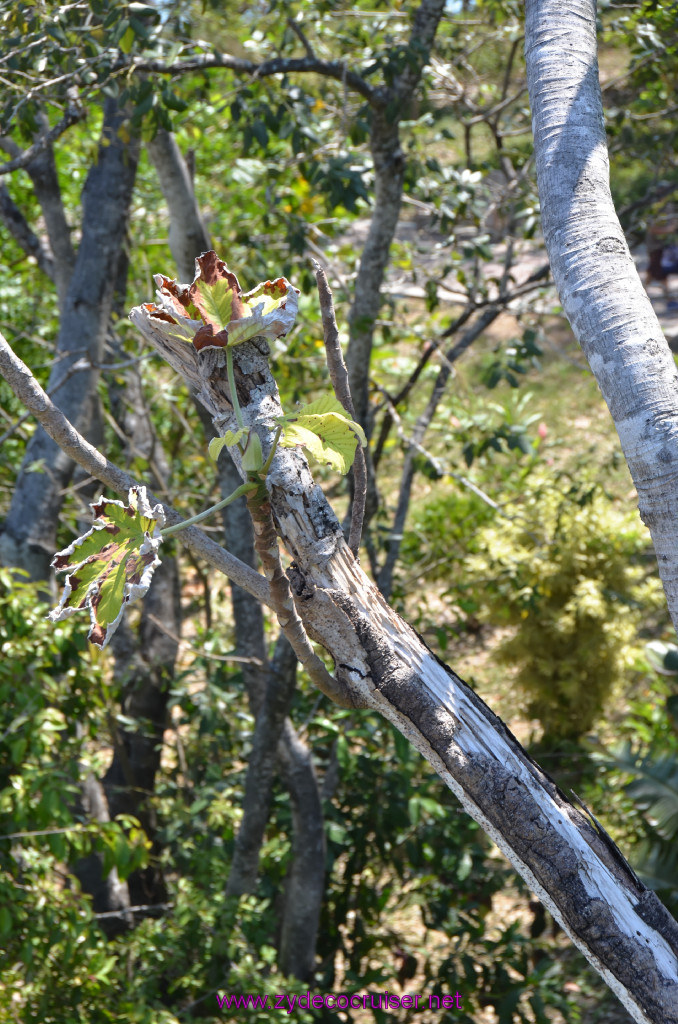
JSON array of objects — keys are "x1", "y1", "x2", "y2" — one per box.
[{"x1": 468, "y1": 473, "x2": 662, "y2": 741}]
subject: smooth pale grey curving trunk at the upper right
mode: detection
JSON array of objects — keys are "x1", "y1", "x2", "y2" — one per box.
[{"x1": 525, "y1": 0, "x2": 678, "y2": 627}]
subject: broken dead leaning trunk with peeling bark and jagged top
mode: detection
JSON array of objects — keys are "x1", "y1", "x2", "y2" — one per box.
[{"x1": 127, "y1": 308, "x2": 678, "y2": 1024}]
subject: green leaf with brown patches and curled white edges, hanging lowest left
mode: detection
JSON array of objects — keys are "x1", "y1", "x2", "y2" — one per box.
[{"x1": 49, "y1": 487, "x2": 165, "y2": 647}]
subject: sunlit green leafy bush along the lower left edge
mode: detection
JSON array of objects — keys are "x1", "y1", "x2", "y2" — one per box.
[{"x1": 0, "y1": 569, "x2": 147, "y2": 1024}]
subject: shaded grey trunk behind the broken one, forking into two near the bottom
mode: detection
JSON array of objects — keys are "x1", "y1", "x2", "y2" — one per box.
[{"x1": 154, "y1": 140, "x2": 325, "y2": 979}]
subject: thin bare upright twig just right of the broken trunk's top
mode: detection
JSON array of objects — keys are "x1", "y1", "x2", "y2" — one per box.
[{"x1": 310, "y1": 257, "x2": 368, "y2": 558}]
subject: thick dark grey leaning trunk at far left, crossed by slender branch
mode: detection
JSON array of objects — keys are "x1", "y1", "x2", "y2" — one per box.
[{"x1": 0, "y1": 100, "x2": 138, "y2": 580}]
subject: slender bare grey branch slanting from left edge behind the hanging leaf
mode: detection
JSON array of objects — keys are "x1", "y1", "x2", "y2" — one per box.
[{"x1": 0, "y1": 334, "x2": 271, "y2": 605}]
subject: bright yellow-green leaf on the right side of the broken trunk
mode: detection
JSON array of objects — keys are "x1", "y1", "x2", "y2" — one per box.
[{"x1": 277, "y1": 394, "x2": 367, "y2": 473}]
